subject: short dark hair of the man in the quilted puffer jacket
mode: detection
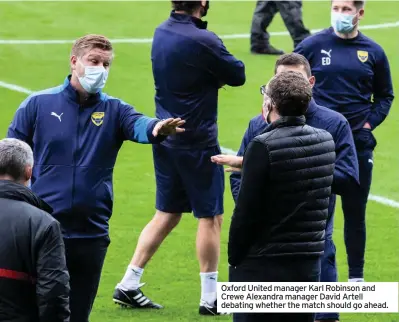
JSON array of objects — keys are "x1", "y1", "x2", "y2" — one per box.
[{"x1": 267, "y1": 71, "x2": 312, "y2": 116}]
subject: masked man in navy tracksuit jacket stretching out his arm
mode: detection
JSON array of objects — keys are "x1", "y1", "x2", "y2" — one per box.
[{"x1": 8, "y1": 35, "x2": 183, "y2": 322}]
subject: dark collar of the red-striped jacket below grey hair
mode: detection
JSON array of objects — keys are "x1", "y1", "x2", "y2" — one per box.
[{"x1": 0, "y1": 180, "x2": 53, "y2": 214}]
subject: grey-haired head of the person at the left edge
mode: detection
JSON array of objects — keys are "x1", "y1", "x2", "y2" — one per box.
[{"x1": 0, "y1": 139, "x2": 33, "y2": 185}]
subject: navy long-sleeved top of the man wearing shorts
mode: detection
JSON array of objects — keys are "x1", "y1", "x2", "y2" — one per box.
[{"x1": 151, "y1": 11, "x2": 245, "y2": 150}]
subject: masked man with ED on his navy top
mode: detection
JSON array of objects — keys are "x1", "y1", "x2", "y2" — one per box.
[{"x1": 295, "y1": 1, "x2": 394, "y2": 300}]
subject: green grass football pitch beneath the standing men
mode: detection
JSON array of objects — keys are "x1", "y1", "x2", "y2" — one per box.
[{"x1": 0, "y1": 1, "x2": 399, "y2": 322}]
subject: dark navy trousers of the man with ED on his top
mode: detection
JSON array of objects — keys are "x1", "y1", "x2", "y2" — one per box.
[{"x1": 342, "y1": 129, "x2": 377, "y2": 278}]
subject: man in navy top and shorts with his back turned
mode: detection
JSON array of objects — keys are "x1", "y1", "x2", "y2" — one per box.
[{"x1": 114, "y1": 1, "x2": 245, "y2": 315}]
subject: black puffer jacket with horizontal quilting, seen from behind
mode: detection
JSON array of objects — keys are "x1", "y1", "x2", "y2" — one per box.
[{"x1": 228, "y1": 117, "x2": 335, "y2": 266}]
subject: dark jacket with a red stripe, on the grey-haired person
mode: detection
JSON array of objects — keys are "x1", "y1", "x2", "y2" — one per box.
[{"x1": 0, "y1": 181, "x2": 70, "y2": 322}]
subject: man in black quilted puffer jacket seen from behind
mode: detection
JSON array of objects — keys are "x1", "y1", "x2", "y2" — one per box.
[{"x1": 228, "y1": 72, "x2": 335, "y2": 322}]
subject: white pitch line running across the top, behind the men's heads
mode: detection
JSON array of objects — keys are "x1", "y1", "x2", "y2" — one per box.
[{"x1": 0, "y1": 21, "x2": 399, "y2": 45}]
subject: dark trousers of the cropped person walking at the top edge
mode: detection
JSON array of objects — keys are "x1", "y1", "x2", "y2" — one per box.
[{"x1": 251, "y1": 1, "x2": 310, "y2": 50}]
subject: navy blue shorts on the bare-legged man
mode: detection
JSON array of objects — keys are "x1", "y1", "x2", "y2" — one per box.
[{"x1": 153, "y1": 144, "x2": 224, "y2": 218}]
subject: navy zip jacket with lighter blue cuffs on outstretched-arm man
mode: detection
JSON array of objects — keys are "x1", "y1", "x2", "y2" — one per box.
[{"x1": 7, "y1": 77, "x2": 162, "y2": 238}]
